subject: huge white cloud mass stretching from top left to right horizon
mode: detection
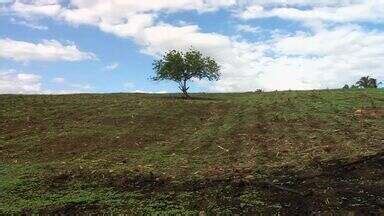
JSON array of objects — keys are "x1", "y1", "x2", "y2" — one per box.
[{"x1": 5, "y1": 0, "x2": 384, "y2": 91}]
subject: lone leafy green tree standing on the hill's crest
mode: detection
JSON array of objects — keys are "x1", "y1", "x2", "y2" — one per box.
[{"x1": 152, "y1": 48, "x2": 220, "y2": 98}]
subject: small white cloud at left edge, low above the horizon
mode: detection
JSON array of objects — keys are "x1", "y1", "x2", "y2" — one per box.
[{"x1": 0, "y1": 71, "x2": 41, "y2": 94}]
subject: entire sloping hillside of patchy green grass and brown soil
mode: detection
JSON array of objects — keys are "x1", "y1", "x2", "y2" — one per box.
[{"x1": 0, "y1": 89, "x2": 384, "y2": 215}]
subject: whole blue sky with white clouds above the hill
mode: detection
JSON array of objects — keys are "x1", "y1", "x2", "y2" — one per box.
[{"x1": 0, "y1": 0, "x2": 384, "y2": 94}]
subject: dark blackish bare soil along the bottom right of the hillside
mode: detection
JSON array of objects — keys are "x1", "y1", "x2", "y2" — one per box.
[{"x1": 42, "y1": 152, "x2": 384, "y2": 215}]
